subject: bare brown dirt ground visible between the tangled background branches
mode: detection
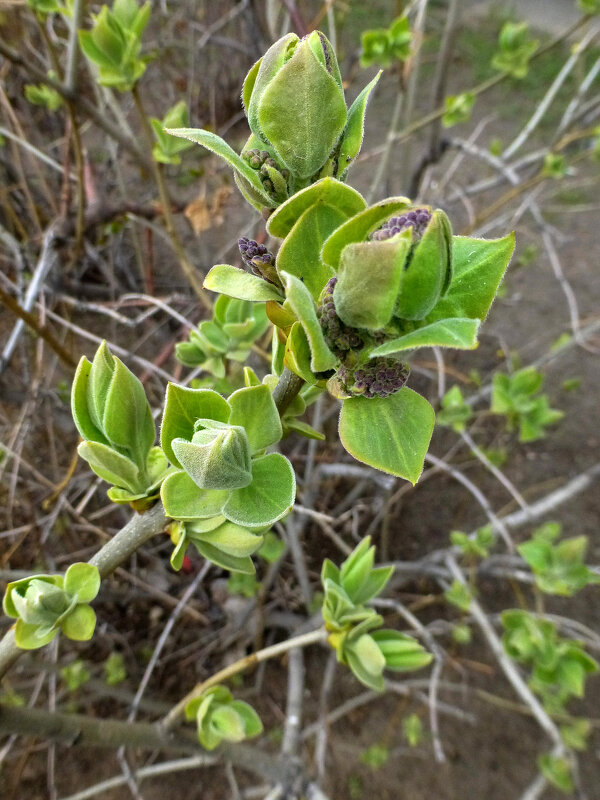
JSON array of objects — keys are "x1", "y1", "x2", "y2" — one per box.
[{"x1": 0, "y1": 0, "x2": 600, "y2": 800}]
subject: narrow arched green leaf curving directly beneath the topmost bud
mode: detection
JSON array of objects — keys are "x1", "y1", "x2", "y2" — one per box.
[{"x1": 267, "y1": 178, "x2": 366, "y2": 239}]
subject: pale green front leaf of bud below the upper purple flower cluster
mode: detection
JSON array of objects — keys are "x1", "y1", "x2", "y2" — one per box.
[{"x1": 333, "y1": 231, "x2": 412, "y2": 330}]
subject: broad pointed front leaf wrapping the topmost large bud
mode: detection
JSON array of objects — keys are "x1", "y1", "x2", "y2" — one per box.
[{"x1": 255, "y1": 39, "x2": 347, "y2": 179}]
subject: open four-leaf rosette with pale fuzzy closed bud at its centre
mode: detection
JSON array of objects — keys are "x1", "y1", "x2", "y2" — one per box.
[{"x1": 161, "y1": 384, "x2": 296, "y2": 531}]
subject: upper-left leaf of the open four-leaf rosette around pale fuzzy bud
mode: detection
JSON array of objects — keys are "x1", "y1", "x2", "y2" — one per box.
[{"x1": 160, "y1": 383, "x2": 231, "y2": 467}]
